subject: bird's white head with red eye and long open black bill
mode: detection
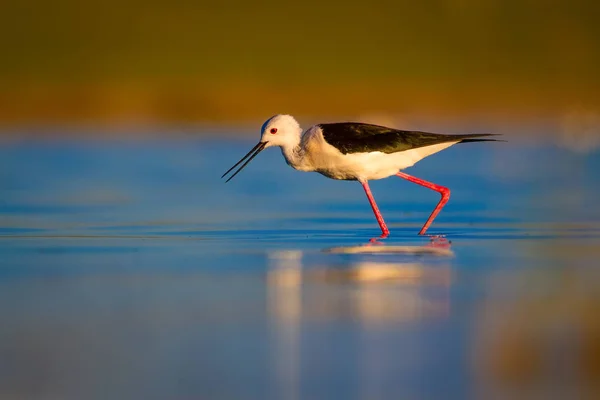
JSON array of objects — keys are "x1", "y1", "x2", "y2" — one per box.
[{"x1": 221, "y1": 114, "x2": 302, "y2": 182}]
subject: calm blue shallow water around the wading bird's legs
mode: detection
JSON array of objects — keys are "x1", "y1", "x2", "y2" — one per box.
[{"x1": 0, "y1": 139, "x2": 600, "y2": 399}]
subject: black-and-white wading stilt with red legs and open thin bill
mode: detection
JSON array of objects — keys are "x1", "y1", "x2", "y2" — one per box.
[{"x1": 221, "y1": 114, "x2": 500, "y2": 239}]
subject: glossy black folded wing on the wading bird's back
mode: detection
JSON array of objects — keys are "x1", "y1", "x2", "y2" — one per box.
[{"x1": 319, "y1": 122, "x2": 496, "y2": 154}]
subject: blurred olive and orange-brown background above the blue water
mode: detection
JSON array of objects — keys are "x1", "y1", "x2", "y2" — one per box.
[{"x1": 0, "y1": 0, "x2": 600, "y2": 128}]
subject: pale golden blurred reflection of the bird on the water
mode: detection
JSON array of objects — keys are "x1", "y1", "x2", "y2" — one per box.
[{"x1": 267, "y1": 244, "x2": 453, "y2": 323}]
